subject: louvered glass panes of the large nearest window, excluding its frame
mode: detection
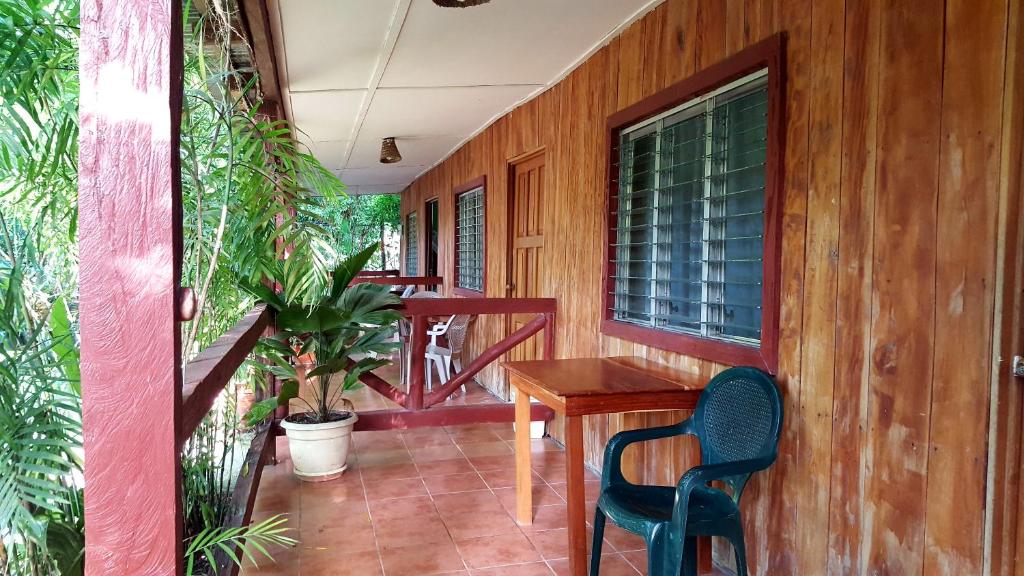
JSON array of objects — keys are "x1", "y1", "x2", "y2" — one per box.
[{"x1": 610, "y1": 71, "x2": 768, "y2": 345}]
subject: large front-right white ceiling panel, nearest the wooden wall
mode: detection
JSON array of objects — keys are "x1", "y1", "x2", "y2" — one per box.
[{"x1": 381, "y1": 0, "x2": 650, "y2": 87}]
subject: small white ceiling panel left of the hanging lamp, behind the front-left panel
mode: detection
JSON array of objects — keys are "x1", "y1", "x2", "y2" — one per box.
[{"x1": 291, "y1": 90, "x2": 367, "y2": 141}]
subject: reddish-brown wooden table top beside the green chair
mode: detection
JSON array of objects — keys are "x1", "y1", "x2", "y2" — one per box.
[{"x1": 502, "y1": 357, "x2": 707, "y2": 415}]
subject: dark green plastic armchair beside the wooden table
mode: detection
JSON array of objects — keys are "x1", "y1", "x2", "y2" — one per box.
[{"x1": 590, "y1": 368, "x2": 782, "y2": 576}]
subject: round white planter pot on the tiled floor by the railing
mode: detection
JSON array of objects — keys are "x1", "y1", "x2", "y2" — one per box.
[{"x1": 281, "y1": 413, "x2": 359, "y2": 482}]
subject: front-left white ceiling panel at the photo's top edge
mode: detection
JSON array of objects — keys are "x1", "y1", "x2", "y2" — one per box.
[{"x1": 279, "y1": 0, "x2": 398, "y2": 92}]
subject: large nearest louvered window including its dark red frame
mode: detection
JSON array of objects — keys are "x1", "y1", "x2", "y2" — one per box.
[{"x1": 602, "y1": 34, "x2": 779, "y2": 371}]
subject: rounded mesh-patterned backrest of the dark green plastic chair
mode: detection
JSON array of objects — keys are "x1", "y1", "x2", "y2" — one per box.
[{"x1": 693, "y1": 367, "x2": 782, "y2": 494}]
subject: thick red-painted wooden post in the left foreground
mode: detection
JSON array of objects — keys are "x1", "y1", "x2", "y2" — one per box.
[{"x1": 78, "y1": 0, "x2": 182, "y2": 576}]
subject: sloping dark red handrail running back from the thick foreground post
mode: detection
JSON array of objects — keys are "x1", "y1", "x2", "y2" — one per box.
[{"x1": 178, "y1": 304, "x2": 270, "y2": 444}]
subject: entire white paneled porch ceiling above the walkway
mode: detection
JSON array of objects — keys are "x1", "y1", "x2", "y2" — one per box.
[{"x1": 268, "y1": 0, "x2": 663, "y2": 194}]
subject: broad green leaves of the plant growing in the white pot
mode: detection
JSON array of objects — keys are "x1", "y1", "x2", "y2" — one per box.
[{"x1": 246, "y1": 245, "x2": 400, "y2": 424}]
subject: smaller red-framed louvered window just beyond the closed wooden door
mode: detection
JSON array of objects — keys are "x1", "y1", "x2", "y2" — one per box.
[{"x1": 455, "y1": 177, "x2": 484, "y2": 296}]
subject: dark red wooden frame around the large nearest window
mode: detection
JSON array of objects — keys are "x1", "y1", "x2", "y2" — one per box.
[{"x1": 601, "y1": 34, "x2": 785, "y2": 374}]
